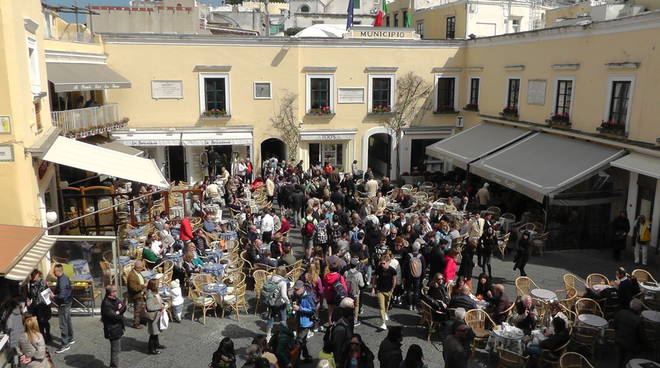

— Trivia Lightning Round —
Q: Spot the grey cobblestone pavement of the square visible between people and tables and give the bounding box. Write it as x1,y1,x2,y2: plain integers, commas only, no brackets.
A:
50,229,658,368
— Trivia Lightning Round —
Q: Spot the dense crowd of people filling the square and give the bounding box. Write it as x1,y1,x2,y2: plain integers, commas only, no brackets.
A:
2,160,656,368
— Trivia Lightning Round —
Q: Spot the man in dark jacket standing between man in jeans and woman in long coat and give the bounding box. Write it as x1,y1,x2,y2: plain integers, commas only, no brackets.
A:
101,285,126,368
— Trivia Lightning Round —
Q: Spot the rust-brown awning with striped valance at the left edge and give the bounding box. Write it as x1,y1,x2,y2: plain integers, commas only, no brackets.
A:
0,225,55,281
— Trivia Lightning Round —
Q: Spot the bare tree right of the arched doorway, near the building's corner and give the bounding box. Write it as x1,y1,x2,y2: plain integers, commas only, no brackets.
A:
383,72,433,179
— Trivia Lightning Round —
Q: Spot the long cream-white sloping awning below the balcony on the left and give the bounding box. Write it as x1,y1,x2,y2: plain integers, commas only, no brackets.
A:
43,137,169,188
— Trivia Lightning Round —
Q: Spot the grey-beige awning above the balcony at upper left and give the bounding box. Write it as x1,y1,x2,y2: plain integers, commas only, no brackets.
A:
46,63,131,92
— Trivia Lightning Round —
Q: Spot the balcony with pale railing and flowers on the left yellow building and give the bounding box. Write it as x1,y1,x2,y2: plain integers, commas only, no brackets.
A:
52,104,128,138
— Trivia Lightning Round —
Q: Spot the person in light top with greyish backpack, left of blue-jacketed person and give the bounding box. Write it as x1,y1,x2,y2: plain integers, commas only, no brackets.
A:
261,266,289,340
